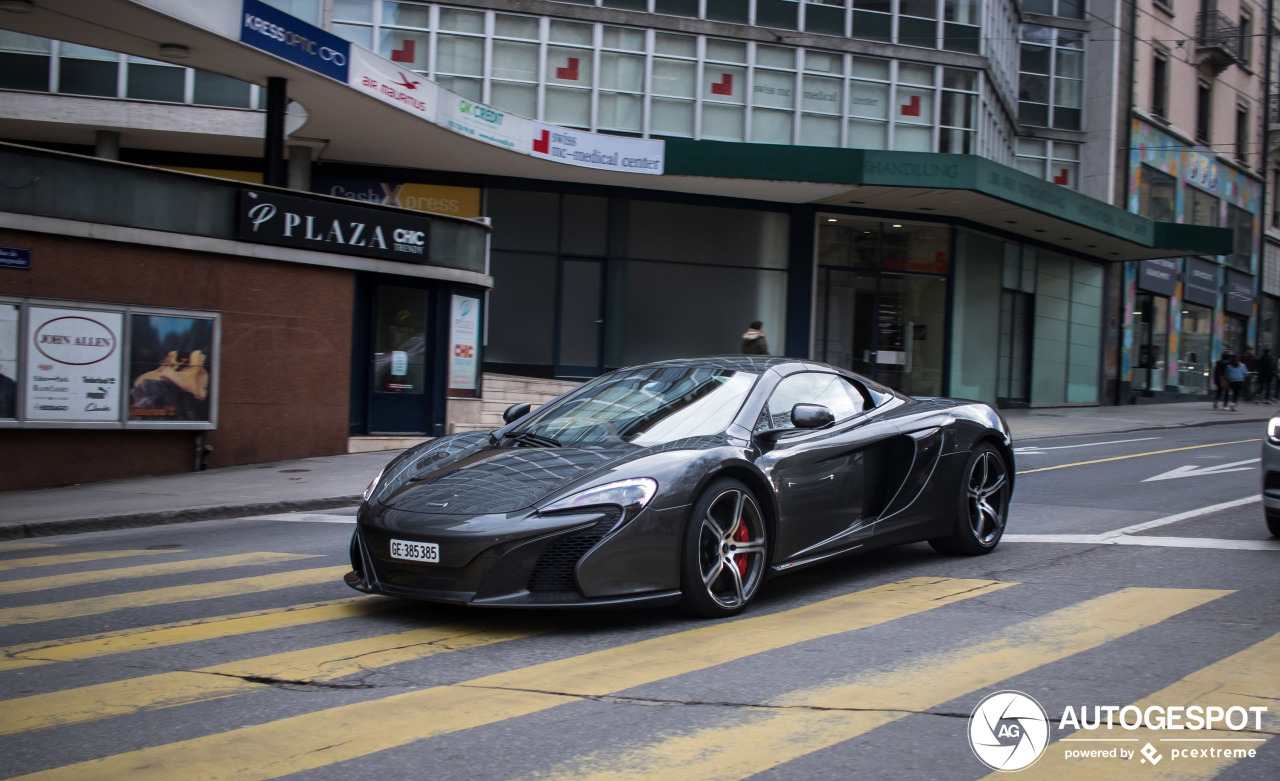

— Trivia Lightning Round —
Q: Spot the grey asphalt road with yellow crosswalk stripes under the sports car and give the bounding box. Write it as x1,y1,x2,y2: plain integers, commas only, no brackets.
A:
0,424,1280,781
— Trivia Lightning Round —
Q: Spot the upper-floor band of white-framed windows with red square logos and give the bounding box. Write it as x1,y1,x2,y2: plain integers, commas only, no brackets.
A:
333,0,982,148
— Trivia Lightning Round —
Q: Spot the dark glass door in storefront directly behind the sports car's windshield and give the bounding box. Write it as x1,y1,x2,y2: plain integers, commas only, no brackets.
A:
556,259,604,378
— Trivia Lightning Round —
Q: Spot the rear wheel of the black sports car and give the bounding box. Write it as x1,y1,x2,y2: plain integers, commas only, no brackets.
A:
929,442,1012,556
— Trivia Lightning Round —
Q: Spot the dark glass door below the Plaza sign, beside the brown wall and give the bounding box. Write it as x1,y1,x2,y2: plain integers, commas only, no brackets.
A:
369,284,431,434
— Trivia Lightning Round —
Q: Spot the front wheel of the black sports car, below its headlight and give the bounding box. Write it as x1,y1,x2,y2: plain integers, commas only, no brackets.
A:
680,478,769,618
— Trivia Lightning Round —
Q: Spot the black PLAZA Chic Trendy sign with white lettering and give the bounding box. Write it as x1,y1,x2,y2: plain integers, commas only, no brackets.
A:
237,189,431,264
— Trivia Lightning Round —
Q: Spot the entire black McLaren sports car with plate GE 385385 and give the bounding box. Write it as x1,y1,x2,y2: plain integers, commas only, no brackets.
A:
346,357,1014,617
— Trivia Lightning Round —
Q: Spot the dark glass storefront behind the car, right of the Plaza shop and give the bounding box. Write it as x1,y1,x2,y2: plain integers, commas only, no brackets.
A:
486,189,790,376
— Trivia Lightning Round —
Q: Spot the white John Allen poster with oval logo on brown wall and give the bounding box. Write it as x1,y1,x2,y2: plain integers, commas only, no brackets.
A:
23,306,124,423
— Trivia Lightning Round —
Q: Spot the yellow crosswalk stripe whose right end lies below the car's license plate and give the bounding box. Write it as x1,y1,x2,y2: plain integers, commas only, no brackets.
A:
0,597,398,672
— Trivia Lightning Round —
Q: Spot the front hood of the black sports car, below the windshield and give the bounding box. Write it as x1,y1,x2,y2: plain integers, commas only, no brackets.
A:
378,443,644,515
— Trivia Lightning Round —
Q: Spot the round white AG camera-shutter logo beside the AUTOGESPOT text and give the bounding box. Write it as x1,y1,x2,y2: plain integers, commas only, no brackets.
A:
969,691,1048,772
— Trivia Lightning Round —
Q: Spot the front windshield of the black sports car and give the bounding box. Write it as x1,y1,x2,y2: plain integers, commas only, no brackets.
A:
517,366,759,447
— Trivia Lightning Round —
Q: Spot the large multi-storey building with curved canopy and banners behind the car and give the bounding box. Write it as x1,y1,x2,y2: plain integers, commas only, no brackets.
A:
0,0,1231,486
